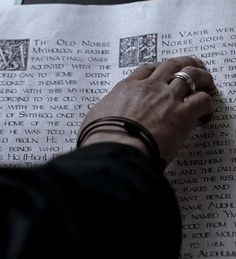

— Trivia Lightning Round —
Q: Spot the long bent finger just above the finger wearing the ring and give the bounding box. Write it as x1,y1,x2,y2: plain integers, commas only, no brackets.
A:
150,57,206,83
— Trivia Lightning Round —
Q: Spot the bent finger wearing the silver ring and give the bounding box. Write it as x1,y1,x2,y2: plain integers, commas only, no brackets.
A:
168,66,216,100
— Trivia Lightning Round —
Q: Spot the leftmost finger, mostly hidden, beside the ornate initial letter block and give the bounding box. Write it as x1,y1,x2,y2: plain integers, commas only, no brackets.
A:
127,62,161,80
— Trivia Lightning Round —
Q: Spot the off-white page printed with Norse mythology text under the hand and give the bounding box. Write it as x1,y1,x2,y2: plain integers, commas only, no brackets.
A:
0,0,236,259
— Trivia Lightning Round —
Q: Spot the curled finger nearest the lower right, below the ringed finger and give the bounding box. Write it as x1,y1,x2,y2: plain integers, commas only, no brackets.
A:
182,92,215,124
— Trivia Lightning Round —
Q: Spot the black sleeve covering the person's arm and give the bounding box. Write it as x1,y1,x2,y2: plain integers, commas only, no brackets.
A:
0,143,181,259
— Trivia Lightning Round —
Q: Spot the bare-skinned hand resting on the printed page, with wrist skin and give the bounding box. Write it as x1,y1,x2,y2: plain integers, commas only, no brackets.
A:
79,57,215,166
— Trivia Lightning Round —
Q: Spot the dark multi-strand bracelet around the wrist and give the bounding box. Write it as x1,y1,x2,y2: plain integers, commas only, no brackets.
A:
77,116,160,159
